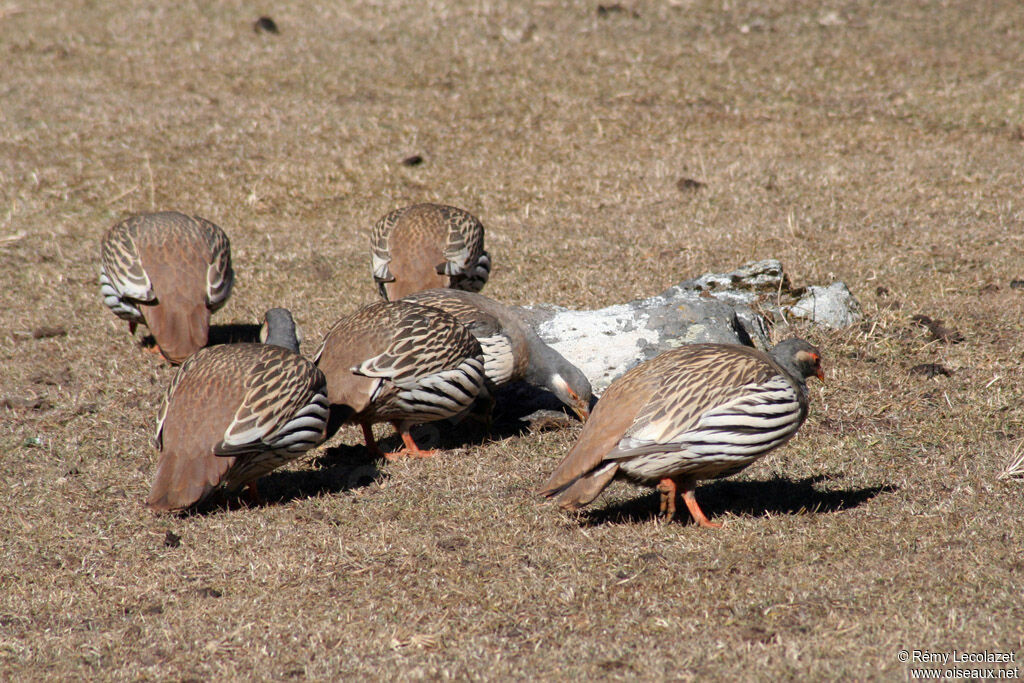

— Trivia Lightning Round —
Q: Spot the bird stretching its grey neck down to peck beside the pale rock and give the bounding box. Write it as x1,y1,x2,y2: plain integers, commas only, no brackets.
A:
402,289,592,422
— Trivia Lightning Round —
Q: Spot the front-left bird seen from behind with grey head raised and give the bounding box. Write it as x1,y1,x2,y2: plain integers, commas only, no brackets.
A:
147,308,330,511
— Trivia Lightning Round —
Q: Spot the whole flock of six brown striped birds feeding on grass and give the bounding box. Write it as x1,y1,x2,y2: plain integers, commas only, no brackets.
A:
99,204,823,527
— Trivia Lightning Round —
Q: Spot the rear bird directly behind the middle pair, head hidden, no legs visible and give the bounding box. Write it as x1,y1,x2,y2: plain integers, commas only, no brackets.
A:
370,204,490,301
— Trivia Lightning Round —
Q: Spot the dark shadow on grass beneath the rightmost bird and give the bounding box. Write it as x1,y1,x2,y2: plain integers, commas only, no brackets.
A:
580,474,898,526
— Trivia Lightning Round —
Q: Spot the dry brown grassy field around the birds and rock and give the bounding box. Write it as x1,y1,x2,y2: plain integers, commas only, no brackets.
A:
0,0,1024,680
